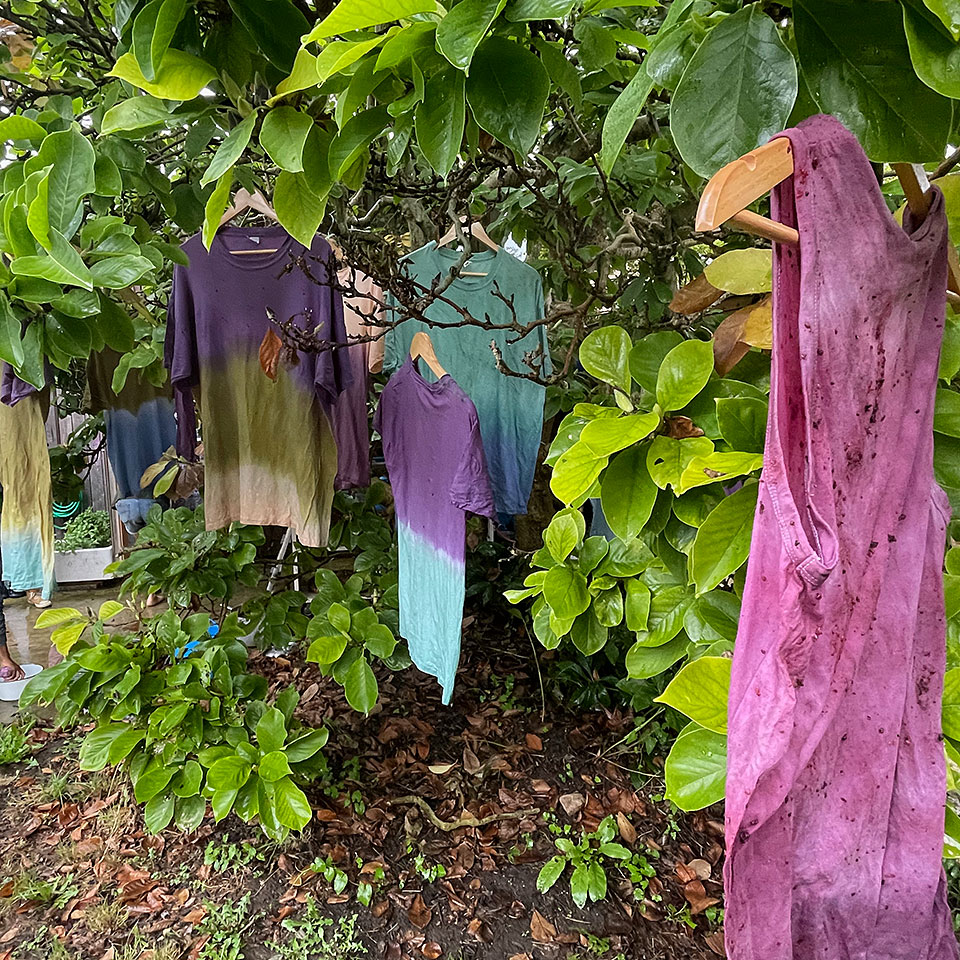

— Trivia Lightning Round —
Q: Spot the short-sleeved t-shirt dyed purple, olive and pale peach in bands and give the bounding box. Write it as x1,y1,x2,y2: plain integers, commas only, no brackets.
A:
166,226,349,547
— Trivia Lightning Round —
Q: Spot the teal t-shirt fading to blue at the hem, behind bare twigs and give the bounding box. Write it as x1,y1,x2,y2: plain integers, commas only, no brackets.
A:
384,242,551,514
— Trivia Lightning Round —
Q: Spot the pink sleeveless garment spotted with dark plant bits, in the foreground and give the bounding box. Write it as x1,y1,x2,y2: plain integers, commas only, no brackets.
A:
724,116,957,960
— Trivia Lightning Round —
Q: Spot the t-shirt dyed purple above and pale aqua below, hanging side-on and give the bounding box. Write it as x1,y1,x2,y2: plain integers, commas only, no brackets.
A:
374,358,494,703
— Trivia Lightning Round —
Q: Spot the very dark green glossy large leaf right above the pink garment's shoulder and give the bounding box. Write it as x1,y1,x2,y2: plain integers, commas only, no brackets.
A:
793,0,953,162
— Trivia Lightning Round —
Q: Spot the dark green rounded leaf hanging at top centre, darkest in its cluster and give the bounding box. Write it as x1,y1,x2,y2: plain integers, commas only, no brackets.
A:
467,36,550,154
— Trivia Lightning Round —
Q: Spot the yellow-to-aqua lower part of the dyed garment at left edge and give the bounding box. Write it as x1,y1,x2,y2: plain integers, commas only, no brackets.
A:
0,393,54,599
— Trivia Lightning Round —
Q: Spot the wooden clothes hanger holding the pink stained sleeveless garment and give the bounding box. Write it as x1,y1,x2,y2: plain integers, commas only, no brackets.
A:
696,137,960,304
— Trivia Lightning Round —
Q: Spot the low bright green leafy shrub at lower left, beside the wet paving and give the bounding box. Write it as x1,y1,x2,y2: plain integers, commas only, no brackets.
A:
21,601,328,840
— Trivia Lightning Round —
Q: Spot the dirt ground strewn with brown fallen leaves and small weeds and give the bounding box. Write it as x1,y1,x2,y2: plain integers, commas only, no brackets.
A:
0,595,723,960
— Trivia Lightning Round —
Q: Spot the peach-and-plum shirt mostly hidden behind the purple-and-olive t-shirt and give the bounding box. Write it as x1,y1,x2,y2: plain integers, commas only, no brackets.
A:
333,267,383,490
